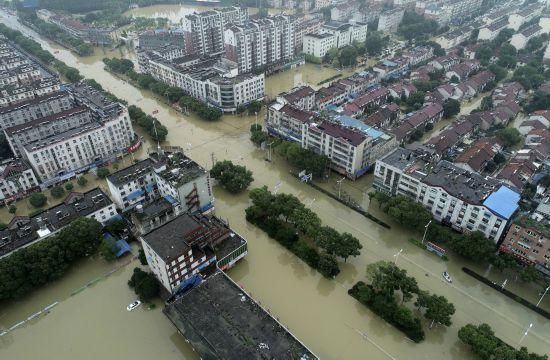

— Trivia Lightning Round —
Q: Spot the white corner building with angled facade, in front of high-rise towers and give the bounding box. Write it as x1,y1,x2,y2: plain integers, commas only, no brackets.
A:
140,53,265,112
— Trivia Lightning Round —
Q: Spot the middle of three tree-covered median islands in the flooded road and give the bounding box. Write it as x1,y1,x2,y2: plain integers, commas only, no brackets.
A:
354,261,455,342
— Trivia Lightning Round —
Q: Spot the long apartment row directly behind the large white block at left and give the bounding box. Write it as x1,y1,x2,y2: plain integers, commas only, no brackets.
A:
4,106,93,157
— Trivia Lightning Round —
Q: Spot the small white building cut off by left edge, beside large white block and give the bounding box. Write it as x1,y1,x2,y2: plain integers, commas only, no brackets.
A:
0,160,39,202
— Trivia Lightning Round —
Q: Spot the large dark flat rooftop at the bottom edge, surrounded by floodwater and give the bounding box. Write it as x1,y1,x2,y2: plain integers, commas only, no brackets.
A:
164,271,317,360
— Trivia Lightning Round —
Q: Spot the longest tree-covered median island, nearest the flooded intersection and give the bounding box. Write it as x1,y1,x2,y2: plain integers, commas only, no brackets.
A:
246,186,363,278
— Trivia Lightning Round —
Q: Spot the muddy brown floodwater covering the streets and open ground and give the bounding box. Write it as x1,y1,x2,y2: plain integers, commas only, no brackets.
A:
0,9,550,360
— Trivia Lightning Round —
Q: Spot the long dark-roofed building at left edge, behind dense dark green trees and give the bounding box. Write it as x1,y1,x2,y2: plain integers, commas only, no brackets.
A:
0,188,116,257
